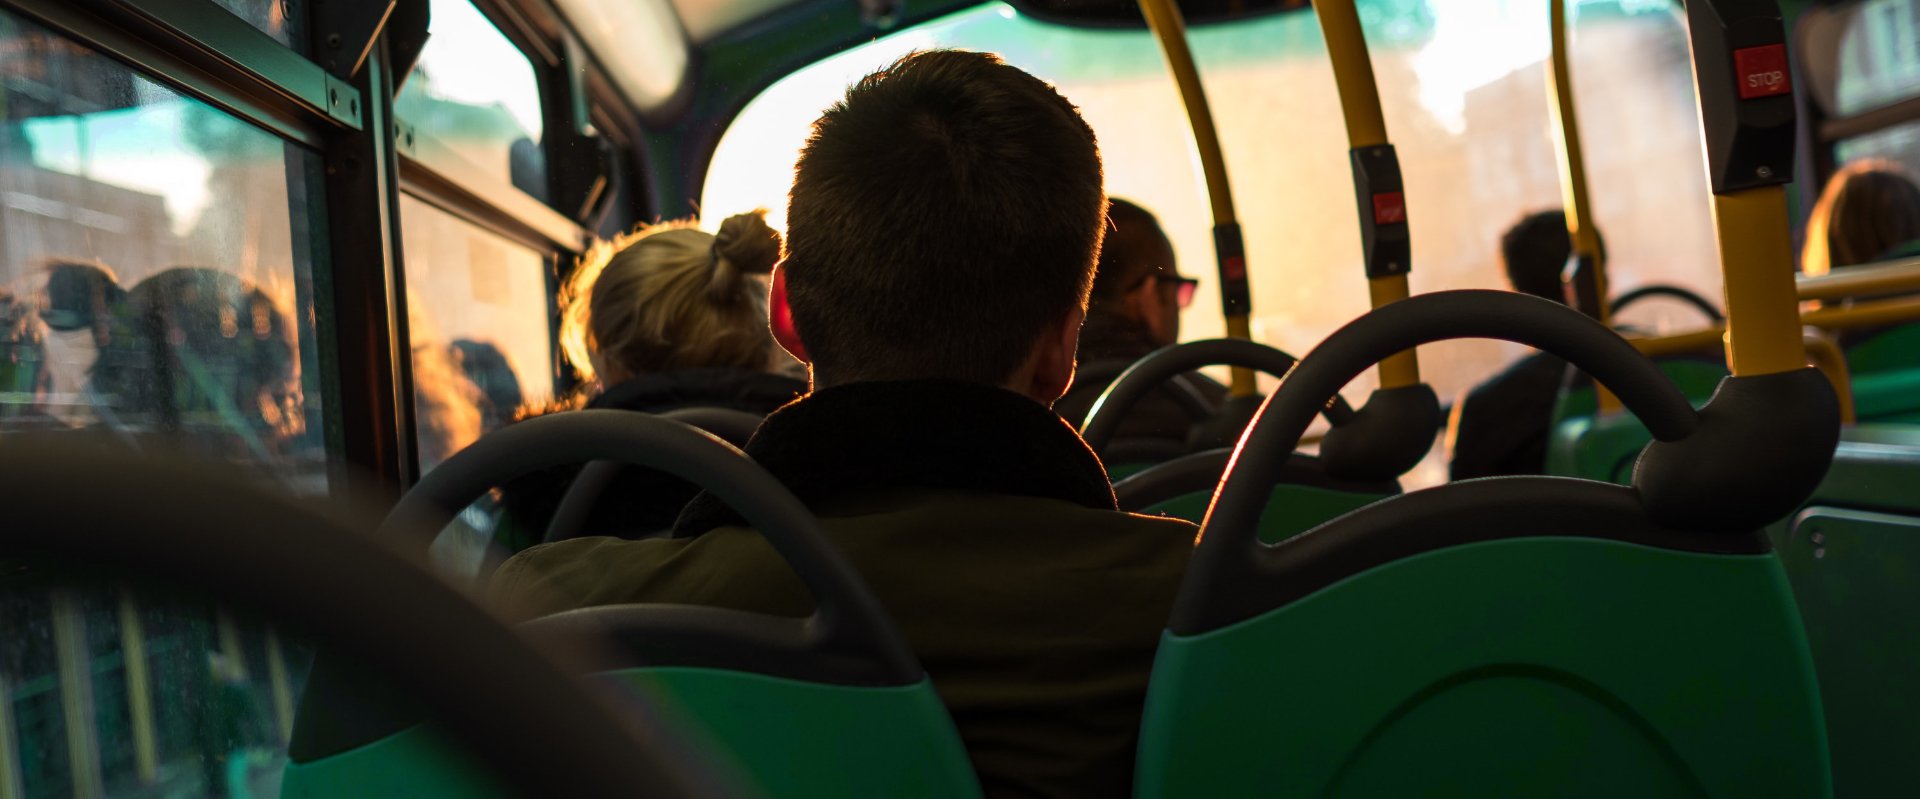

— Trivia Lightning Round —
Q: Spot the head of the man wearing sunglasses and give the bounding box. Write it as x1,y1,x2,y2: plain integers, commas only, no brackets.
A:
1087,200,1194,346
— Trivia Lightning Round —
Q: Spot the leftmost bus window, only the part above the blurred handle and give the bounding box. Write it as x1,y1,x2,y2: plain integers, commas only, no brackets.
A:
0,13,324,492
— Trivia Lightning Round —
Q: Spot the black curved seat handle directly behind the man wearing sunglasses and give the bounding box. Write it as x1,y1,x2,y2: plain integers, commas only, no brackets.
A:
1081,338,1354,451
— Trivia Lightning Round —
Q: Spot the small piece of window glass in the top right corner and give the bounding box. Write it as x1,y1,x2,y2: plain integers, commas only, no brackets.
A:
1836,0,1920,115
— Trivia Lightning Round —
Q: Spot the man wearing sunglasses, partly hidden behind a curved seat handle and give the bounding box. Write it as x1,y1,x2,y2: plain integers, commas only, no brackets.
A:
1054,200,1227,451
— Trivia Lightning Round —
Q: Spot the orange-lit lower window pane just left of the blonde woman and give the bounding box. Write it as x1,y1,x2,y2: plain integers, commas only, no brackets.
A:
399,196,555,469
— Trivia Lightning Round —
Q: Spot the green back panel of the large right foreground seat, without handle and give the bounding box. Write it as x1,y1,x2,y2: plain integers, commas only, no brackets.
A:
1137,533,1830,797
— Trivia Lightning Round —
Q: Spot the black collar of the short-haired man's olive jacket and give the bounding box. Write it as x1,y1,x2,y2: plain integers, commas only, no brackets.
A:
674,380,1116,536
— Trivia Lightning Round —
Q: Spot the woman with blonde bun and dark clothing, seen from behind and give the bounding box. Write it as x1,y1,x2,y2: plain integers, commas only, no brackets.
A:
501,211,806,549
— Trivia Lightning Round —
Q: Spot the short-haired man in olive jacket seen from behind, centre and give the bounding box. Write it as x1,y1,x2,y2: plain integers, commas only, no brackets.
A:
492,50,1196,797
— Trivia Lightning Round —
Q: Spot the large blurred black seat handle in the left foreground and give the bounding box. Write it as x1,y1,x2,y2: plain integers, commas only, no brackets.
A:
0,443,722,797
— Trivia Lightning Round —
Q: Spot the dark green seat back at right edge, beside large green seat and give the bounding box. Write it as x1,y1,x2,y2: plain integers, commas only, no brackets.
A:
1768,428,1920,797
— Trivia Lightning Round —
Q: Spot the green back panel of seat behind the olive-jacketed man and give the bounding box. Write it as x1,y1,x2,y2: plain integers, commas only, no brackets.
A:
282,666,979,799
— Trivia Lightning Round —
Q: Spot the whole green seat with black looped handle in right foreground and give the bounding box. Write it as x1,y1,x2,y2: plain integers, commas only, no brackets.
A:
1135,292,1837,797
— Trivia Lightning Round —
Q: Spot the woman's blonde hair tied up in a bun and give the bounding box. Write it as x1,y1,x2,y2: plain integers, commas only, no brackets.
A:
561,209,780,382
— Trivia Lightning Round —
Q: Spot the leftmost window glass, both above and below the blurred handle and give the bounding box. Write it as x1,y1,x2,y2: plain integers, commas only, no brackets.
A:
0,4,326,797
